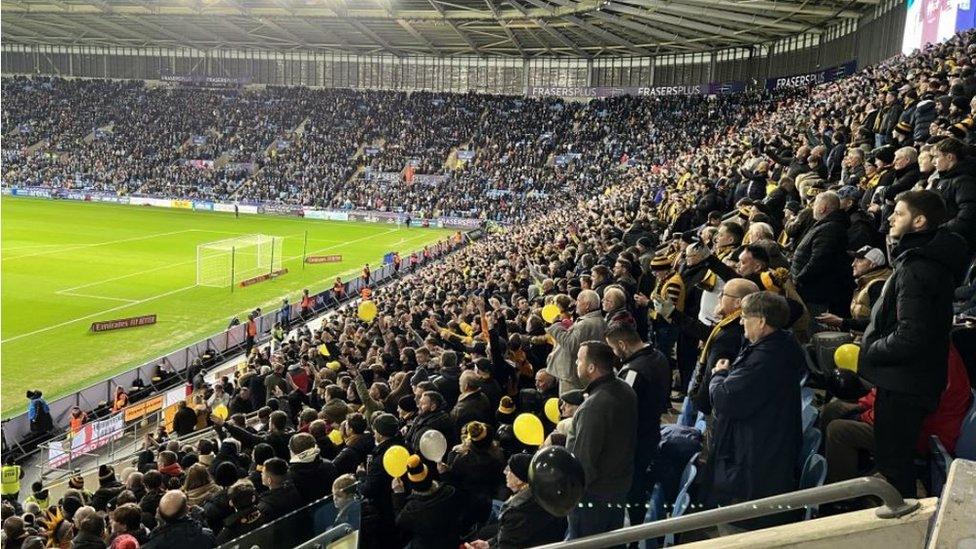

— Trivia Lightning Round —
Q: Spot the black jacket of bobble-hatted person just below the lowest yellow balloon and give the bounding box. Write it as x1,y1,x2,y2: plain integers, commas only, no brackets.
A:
393,484,461,549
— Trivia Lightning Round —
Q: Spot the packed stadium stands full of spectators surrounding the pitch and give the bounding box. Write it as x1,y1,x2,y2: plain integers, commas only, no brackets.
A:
3,15,976,549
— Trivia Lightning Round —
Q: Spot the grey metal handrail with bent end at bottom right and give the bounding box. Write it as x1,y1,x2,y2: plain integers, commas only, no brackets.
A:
535,477,919,549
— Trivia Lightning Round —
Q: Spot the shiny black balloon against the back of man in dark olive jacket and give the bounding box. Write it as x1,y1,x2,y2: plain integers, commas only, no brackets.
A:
529,446,586,517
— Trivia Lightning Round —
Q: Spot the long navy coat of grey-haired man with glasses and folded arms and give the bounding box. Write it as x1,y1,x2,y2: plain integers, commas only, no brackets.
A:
703,330,806,524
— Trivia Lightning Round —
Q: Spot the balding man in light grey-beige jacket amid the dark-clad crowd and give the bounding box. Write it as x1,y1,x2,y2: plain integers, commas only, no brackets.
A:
546,290,606,394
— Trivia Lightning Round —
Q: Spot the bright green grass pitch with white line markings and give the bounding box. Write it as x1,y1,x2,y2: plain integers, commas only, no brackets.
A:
0,197,453,417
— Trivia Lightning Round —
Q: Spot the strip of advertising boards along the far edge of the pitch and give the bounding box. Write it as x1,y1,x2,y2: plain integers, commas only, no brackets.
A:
3,187,482,229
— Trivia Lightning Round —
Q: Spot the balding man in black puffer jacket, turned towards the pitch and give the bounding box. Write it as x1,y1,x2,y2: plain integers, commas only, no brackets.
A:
790,191,854,315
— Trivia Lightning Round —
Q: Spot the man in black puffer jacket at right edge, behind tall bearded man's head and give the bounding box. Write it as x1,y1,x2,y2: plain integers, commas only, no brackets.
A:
934,137,976,248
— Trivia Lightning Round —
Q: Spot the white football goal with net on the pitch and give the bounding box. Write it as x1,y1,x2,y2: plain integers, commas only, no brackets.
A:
197,234,283,288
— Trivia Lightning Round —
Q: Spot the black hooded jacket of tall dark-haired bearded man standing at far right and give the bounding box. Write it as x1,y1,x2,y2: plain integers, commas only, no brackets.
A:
858,228,968,400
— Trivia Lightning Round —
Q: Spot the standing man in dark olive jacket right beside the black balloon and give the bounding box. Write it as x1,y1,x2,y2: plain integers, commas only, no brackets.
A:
566,340,638,539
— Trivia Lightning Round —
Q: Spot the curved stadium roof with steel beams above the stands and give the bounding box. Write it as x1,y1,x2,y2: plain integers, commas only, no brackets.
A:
0,0,879,57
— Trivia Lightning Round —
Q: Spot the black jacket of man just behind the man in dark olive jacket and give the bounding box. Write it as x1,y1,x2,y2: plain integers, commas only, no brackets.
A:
617,345,671,465
